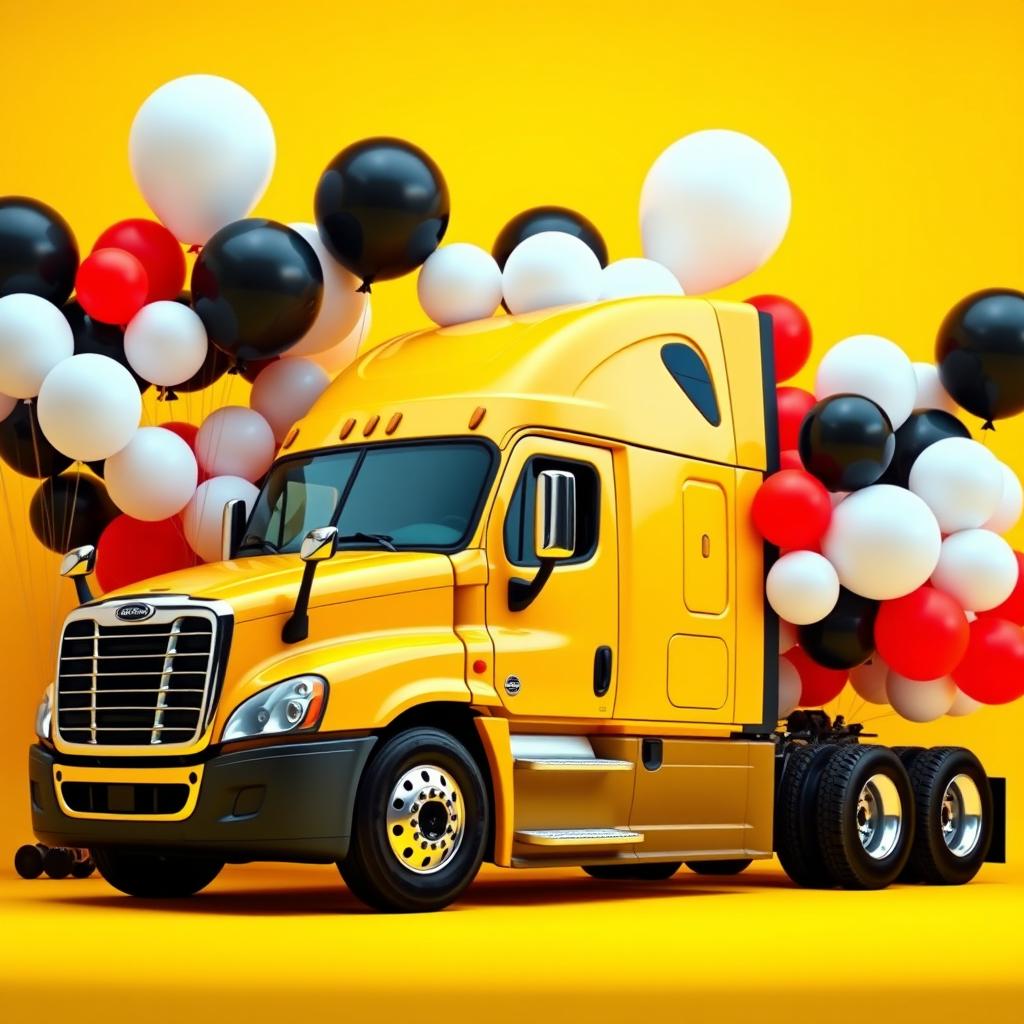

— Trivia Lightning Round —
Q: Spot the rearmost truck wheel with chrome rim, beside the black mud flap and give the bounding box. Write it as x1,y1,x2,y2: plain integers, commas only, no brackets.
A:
905,746,993,886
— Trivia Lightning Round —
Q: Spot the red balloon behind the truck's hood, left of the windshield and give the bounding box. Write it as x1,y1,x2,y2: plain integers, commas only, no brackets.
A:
96,515,200,592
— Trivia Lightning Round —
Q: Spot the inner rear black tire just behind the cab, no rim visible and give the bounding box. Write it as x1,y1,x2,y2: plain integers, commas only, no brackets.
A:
775,743,840,889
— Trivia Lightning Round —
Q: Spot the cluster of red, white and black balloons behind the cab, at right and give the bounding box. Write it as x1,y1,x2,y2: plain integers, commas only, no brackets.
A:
750,291,1024,722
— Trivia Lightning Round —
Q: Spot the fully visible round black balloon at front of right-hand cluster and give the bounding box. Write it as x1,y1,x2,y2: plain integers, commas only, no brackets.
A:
799,394,896,490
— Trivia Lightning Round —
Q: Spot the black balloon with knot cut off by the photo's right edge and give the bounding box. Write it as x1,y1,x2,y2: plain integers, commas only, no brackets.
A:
935,288,1024,427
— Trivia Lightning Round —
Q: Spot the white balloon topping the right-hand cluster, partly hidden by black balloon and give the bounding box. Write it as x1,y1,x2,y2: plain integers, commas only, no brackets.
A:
814,334,918,430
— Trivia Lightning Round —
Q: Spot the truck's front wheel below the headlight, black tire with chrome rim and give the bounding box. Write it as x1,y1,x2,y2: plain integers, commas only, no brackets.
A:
338,728,490,913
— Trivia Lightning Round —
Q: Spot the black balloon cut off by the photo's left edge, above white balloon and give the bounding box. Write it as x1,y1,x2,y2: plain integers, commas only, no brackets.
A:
0,196,78,306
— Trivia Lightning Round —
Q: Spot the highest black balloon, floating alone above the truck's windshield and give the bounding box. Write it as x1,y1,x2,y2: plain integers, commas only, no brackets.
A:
315,138,451,291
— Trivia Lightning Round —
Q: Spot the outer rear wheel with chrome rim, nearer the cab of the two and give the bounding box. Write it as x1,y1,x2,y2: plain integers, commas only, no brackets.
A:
818,746,913,889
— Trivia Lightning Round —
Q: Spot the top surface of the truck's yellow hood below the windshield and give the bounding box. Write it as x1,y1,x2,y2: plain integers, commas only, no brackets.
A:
103,551,454,623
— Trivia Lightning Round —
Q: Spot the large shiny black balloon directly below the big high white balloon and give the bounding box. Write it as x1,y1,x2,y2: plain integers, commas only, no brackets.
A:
191,218,324,360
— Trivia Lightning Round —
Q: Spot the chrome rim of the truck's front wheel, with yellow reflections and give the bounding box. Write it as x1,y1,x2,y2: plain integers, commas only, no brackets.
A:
386,765,466,874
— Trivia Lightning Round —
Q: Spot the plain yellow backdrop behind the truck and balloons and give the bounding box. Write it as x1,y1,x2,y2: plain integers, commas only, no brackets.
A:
0,0,1024,1014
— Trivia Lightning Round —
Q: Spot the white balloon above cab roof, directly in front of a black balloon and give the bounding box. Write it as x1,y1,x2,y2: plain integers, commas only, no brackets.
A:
502,231,601,313
